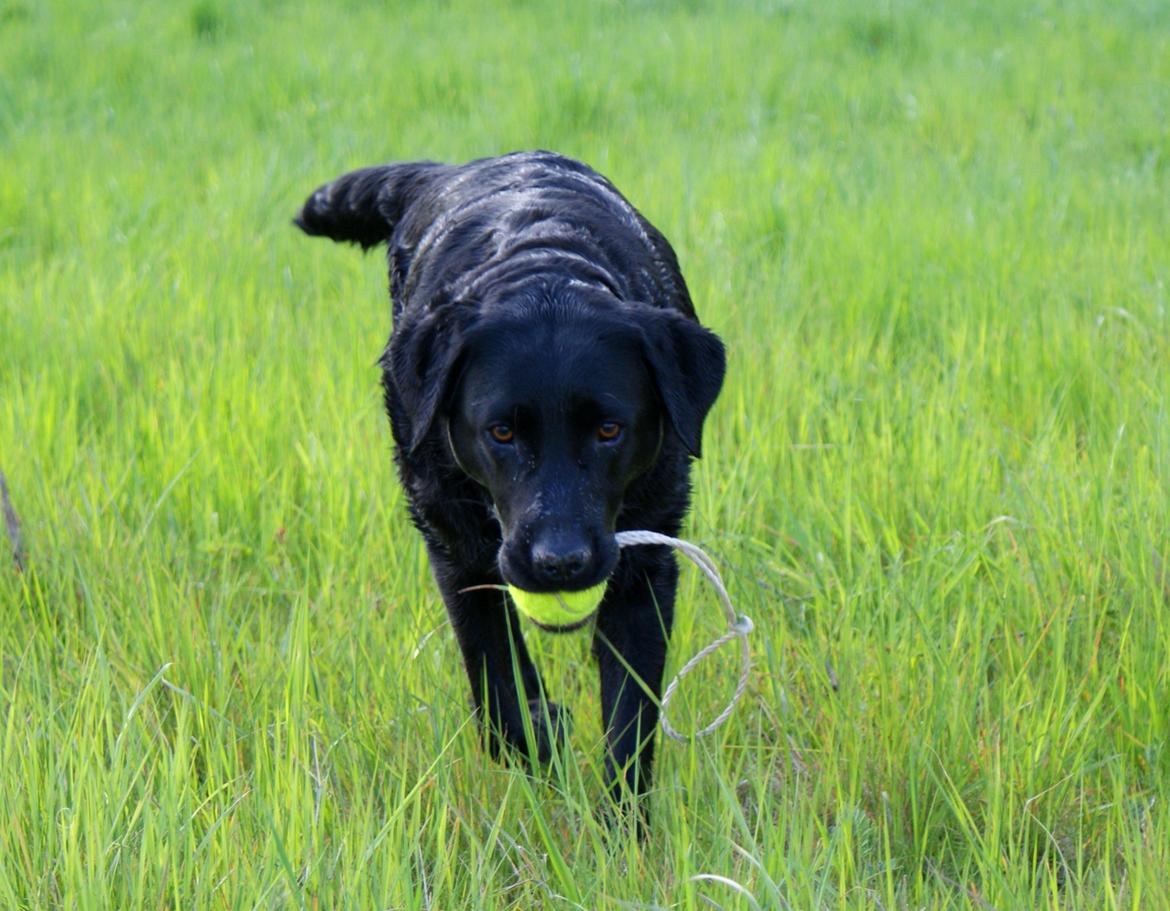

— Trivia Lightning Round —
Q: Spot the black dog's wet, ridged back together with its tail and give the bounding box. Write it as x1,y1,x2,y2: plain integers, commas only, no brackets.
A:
296,152,694,318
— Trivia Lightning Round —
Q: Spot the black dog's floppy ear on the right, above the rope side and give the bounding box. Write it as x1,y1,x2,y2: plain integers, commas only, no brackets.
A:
642,309,727,458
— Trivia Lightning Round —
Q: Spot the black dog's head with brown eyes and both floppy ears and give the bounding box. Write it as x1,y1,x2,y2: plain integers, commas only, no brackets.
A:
384,292,724,592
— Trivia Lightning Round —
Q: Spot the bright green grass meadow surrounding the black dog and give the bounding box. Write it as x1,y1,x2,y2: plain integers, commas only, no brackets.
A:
0,0,1170,911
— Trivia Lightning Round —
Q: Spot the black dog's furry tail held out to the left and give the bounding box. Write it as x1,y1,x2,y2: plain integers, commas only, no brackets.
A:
294,161,447,249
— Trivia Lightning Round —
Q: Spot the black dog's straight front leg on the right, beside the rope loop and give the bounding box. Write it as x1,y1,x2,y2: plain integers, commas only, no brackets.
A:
593,547,679,823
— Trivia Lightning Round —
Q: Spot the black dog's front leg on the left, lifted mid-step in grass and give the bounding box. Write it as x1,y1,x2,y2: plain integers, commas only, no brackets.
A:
432,553,567,762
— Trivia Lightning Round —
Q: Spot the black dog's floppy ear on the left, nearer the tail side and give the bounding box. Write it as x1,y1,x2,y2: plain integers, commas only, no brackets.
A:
379,304,470,455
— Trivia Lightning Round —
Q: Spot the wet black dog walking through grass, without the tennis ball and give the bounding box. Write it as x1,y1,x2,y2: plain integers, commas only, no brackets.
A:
296,152,724,818
